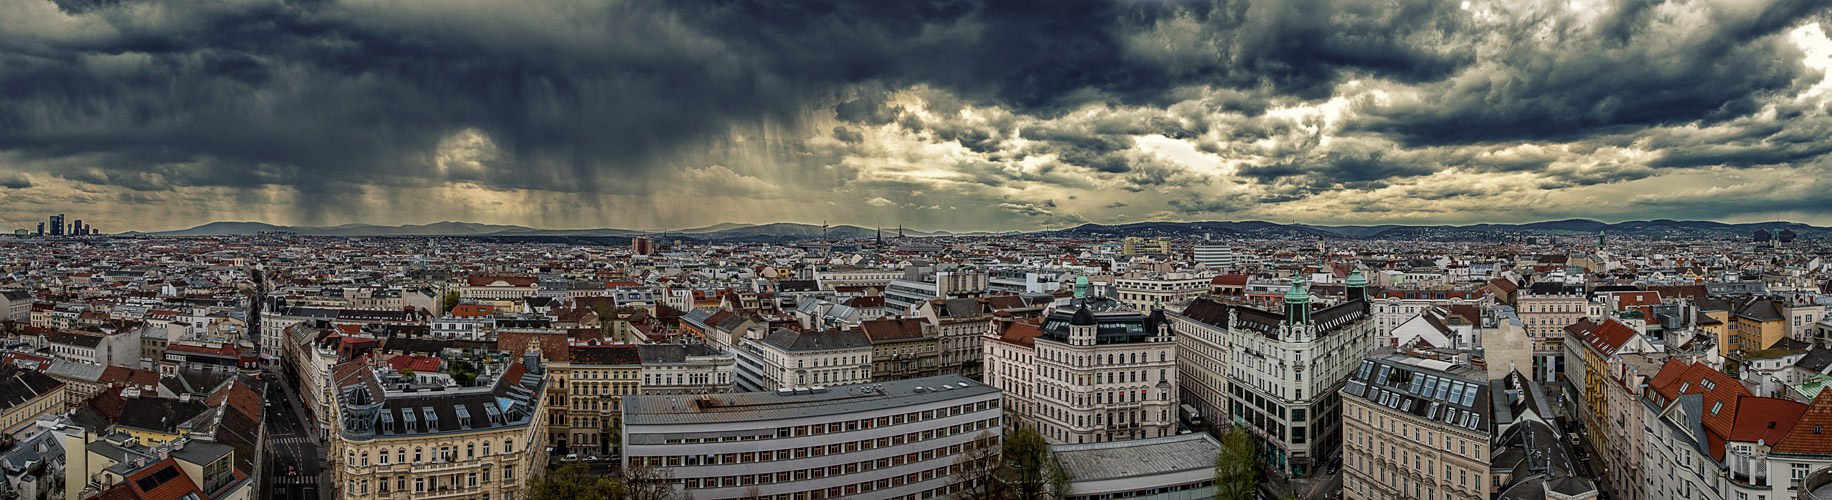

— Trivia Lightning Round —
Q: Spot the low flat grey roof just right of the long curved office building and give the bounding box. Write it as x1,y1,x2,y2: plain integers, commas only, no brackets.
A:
1050,432,1222,482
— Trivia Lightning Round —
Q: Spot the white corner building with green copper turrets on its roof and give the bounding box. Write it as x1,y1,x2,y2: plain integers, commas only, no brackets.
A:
1226,273,1381,476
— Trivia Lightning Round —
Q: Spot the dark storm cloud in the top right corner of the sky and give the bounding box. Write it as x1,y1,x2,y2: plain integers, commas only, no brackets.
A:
1354,0,1828,145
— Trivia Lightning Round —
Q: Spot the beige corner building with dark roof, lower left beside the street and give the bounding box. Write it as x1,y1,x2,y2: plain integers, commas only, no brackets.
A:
330,355,548,500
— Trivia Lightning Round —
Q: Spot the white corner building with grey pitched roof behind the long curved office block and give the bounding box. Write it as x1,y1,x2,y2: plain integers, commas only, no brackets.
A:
736,328,872,390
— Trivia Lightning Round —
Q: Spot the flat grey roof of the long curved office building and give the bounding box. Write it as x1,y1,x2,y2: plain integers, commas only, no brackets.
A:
623,375,998,425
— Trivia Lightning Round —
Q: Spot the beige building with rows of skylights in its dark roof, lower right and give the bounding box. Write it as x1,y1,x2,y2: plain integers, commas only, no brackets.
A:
1341,353,1493,500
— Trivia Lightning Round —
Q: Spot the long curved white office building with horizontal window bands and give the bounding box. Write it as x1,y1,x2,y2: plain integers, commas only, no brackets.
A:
623,375,1004,498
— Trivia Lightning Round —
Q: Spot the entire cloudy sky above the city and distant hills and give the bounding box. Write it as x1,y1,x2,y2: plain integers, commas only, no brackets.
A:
0,0,1832,233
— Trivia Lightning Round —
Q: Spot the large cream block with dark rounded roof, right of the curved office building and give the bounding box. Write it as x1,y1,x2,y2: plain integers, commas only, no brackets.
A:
1031,297,1178,443
